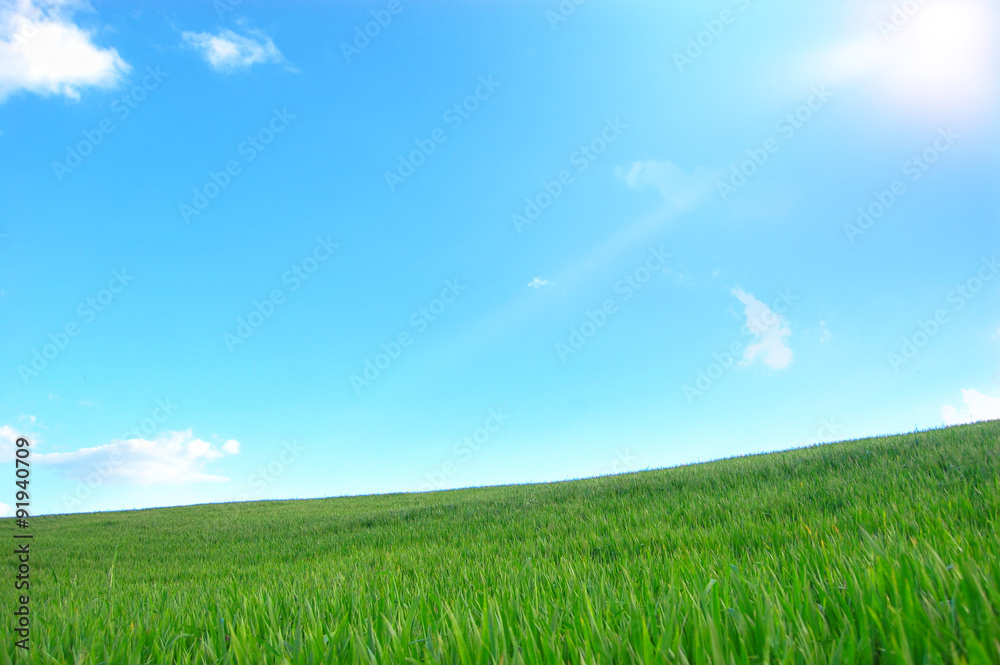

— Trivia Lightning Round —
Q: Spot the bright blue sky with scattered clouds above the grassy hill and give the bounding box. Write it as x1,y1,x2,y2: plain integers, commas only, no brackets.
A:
0,0,1000,513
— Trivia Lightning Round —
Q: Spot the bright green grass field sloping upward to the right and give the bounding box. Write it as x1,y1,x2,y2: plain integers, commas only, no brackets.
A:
2,421,1000,664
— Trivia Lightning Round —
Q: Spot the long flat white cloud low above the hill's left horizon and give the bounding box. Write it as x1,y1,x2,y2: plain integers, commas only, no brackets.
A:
36,430,240,485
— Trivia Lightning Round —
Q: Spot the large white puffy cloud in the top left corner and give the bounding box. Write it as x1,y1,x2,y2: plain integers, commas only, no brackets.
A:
0,0,131,102
